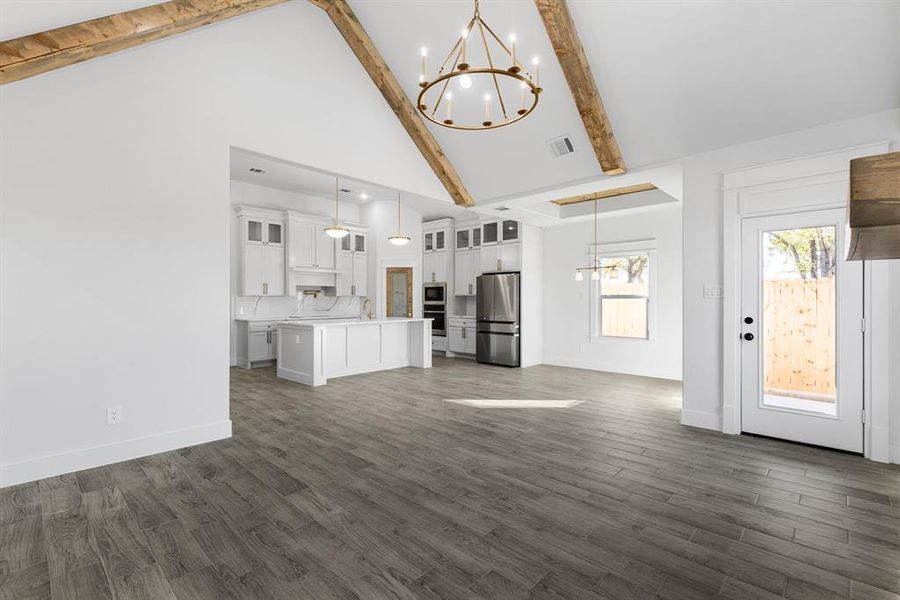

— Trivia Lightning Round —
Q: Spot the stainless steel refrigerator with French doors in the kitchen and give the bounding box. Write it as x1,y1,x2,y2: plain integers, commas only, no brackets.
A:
475,273,520,367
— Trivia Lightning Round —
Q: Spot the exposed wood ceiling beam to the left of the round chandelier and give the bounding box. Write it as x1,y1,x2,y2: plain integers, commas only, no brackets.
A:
310,0,475,206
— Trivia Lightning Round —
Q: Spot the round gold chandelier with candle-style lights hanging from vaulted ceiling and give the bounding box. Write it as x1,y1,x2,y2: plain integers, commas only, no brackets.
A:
416,0,543,131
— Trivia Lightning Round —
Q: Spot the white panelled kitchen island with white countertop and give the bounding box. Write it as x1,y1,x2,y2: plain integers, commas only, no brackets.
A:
277,318,431,386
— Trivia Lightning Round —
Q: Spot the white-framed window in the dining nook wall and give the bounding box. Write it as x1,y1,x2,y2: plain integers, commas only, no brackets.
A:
591,252,652,339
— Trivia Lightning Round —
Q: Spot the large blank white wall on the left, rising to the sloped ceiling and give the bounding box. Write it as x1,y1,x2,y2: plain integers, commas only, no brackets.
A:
0,2,446,485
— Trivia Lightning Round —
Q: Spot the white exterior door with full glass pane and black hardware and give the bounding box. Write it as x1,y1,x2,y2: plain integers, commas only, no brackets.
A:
739,209,863,452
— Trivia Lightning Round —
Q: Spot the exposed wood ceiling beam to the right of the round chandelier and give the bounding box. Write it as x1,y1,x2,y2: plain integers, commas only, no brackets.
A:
535,0,626,175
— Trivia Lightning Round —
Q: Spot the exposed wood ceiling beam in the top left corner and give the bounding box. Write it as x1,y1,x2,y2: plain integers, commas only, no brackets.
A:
0,0,286,84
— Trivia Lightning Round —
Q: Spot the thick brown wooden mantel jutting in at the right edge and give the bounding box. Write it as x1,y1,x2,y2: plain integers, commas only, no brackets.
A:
847,152,900,260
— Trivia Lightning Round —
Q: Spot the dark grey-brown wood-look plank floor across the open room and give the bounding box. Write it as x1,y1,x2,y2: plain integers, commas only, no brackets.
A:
0,359,900,600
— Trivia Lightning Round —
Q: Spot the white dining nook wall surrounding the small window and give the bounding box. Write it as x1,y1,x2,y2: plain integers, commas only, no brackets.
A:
544,204,682,379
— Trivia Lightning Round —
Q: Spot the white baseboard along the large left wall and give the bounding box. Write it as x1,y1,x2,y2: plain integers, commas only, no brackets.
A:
0,420,231,488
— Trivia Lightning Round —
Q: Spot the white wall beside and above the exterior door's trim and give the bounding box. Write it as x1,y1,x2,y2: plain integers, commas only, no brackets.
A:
682,110,900,450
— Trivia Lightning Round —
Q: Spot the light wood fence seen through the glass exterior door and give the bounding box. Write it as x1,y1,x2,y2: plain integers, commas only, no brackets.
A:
763,277,836,402
